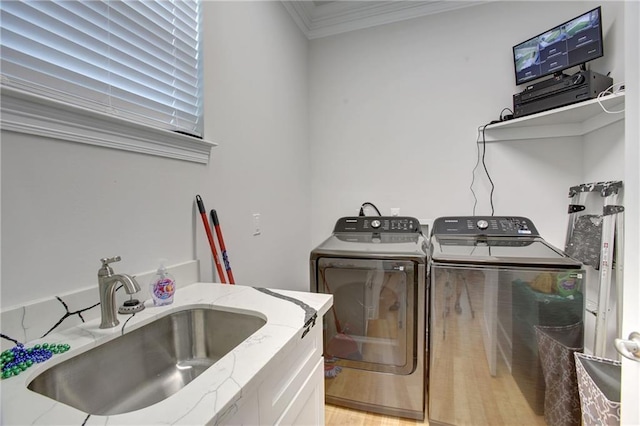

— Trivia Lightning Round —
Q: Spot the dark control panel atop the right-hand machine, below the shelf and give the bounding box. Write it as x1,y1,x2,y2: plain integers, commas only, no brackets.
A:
433,216,540,237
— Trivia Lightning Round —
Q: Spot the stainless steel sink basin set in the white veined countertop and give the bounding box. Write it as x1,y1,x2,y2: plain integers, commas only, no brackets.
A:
28,308,265,415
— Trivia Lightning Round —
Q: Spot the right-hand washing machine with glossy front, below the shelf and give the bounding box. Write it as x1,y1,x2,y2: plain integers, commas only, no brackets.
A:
429,216,584,425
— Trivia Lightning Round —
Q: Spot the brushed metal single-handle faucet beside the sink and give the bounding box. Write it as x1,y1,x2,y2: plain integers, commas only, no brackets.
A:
98,256,140,328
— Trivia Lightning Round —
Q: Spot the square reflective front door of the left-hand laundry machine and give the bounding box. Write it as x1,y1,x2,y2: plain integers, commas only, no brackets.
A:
316,258,418,374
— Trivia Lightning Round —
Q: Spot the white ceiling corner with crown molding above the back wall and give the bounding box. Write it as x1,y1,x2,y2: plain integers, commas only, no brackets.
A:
282,0,486,39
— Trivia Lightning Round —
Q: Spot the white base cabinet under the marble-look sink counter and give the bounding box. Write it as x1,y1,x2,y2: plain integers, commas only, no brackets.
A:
219,325,324,425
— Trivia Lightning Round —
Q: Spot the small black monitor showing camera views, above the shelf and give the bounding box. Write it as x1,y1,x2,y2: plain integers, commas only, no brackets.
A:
513,7,604,85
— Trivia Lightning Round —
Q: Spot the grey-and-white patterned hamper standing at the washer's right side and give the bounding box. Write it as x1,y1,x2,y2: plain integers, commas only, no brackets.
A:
574,352,621,426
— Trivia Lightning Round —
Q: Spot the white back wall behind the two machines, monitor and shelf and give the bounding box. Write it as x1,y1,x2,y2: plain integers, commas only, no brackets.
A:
310,1,624,250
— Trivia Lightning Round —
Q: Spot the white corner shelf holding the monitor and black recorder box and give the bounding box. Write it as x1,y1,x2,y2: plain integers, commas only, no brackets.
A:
480,93,625,142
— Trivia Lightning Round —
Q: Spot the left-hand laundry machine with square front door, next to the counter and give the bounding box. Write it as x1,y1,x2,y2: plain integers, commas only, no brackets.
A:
310,216,428,419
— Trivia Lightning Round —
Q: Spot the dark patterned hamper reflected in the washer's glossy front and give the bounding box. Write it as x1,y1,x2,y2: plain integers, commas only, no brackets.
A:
534,321,584,426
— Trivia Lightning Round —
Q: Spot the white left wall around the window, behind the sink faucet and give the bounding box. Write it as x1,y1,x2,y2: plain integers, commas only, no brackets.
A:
1,2,310,309
